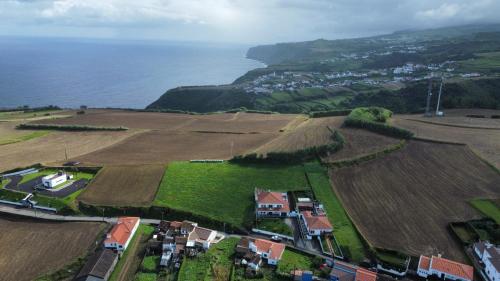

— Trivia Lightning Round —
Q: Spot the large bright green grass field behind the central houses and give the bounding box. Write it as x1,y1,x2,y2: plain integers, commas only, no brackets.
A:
153,162,308,227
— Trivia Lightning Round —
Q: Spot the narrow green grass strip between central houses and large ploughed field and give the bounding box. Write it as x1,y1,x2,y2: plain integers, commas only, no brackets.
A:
306,164,365,262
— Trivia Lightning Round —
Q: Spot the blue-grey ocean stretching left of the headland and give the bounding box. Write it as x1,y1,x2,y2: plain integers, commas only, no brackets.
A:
0,37,263,108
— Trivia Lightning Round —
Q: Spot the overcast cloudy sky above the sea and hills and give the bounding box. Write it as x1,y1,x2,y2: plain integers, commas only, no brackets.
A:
0,0,500,44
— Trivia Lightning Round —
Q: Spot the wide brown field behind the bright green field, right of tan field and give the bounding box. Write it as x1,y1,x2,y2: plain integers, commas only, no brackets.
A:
75,131,277,165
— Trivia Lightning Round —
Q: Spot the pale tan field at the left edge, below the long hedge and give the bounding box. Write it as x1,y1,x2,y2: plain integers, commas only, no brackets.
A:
0,128,136,171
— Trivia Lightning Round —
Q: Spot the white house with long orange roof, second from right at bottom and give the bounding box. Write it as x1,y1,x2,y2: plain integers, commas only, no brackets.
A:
417,255,474,281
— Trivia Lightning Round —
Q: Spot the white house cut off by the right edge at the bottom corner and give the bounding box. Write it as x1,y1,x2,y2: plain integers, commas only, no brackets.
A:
474,241,500,281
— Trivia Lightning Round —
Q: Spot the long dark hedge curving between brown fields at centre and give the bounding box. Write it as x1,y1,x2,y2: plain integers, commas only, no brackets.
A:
229,126,345,164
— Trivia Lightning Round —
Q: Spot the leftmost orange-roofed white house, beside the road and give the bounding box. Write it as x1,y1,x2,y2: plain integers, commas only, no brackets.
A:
104,217,141,251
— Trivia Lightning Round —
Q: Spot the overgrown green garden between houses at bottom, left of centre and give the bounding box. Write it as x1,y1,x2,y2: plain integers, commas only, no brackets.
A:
178,238,239,281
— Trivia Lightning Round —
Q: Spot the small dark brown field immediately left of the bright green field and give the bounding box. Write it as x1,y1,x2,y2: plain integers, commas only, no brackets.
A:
78,165,165,206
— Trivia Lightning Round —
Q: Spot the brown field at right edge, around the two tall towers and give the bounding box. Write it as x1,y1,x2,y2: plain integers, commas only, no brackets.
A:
393,111,500,168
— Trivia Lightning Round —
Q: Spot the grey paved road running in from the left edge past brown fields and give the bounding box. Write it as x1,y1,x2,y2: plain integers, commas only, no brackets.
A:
0,204,160,224
